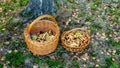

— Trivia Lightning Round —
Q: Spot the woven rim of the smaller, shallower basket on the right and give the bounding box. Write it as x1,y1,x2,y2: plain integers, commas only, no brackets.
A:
61,28,90,49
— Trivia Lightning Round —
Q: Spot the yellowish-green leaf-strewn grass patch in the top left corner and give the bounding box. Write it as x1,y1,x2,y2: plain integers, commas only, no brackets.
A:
0,0,29,24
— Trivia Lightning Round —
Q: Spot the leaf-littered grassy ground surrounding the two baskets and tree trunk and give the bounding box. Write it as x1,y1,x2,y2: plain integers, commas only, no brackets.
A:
0,0,120,68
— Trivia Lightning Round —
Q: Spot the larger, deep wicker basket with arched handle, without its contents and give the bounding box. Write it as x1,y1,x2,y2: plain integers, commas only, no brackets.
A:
24,15,60,55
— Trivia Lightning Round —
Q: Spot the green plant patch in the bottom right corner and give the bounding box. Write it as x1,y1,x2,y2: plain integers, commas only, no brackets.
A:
104,57,119,68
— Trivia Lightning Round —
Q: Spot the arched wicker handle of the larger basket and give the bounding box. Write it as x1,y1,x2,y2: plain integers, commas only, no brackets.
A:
28,14,57,32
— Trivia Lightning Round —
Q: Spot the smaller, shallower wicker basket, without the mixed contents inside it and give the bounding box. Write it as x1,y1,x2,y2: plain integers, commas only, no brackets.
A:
61,28,90,53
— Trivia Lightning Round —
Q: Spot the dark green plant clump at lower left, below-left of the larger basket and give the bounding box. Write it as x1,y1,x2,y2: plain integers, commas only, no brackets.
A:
6,51,25,66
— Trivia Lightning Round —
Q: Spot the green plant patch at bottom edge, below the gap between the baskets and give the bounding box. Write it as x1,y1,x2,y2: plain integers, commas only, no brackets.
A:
46,59,65,68
